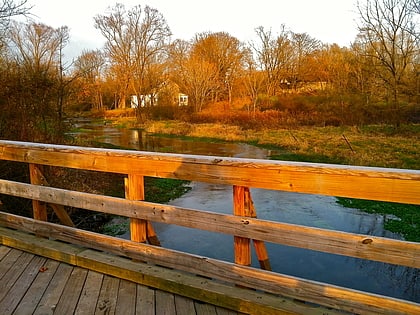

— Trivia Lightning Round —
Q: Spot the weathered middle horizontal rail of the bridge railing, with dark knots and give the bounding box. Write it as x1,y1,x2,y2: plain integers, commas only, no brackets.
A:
0,180,420,268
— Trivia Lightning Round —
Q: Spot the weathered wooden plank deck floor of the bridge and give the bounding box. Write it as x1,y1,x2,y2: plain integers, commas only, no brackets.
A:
0,246,238,315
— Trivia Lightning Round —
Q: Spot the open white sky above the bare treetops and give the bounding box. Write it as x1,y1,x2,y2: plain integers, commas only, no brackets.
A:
24,0,357,58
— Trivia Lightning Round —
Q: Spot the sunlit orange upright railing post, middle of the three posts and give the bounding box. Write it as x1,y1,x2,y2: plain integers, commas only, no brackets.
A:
124,174,147,243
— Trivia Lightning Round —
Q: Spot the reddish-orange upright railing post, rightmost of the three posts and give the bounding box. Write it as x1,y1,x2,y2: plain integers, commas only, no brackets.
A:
233,186,251,266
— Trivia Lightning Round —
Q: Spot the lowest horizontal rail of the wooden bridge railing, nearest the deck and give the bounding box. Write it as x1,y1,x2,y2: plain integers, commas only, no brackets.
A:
0,217,420,315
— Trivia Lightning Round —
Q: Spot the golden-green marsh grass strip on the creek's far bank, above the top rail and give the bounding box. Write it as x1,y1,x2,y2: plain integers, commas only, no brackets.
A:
143,121,420,169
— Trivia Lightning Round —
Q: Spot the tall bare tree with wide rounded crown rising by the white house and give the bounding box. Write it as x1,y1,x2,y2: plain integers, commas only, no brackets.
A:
95,4,171,108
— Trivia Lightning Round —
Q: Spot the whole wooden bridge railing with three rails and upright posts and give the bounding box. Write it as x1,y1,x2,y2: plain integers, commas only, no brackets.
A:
0,141,420,314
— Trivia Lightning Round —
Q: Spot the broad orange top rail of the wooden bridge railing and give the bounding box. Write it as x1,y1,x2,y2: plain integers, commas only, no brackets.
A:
0,140,420,204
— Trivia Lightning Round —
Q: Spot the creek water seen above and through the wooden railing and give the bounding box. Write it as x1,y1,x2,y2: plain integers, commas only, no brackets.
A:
72,120,420,302
